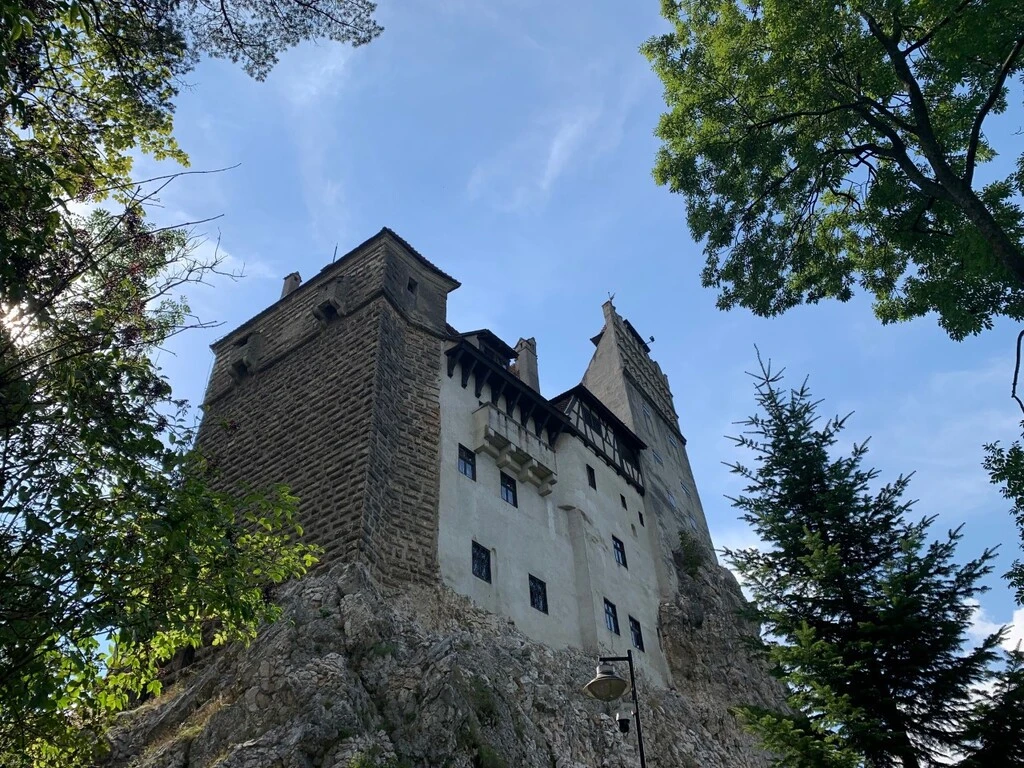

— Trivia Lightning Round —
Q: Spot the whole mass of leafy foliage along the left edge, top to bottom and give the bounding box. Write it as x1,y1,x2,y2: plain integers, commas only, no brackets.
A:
0,0,381,765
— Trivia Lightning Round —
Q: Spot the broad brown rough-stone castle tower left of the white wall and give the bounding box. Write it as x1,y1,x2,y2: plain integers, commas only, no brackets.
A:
199,228,459,584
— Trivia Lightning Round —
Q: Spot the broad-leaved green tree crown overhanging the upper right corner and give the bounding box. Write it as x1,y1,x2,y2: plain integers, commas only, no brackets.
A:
643,0,1024,339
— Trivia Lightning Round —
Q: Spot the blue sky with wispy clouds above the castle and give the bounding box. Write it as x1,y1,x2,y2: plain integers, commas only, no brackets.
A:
138,0,1024,647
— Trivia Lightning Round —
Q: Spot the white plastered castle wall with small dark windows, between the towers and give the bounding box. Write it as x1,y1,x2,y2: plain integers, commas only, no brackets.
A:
437,361,669,685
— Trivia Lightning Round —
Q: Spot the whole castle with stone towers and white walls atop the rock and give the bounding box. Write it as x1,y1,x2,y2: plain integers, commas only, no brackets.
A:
199,228,711,685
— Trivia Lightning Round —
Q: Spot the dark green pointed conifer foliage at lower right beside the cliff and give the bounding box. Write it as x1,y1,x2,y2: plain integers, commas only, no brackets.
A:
726,367,1024,768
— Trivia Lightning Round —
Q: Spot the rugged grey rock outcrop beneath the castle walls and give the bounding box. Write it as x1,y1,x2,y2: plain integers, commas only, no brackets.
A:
110,553,779,768
